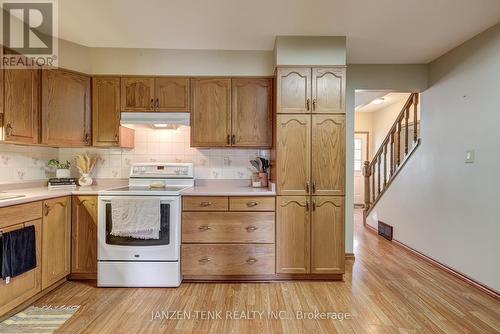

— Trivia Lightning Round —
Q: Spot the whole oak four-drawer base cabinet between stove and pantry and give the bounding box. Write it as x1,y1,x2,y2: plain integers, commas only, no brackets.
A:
181,196,276,281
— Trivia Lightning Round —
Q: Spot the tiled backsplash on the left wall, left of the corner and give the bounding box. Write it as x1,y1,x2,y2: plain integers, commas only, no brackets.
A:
0,144,59,183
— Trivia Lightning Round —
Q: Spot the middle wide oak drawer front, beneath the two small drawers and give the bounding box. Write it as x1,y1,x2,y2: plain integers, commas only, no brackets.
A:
182,212,274,243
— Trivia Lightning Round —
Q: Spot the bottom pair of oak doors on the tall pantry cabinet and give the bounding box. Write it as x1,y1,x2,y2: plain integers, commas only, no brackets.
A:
276,196,345,274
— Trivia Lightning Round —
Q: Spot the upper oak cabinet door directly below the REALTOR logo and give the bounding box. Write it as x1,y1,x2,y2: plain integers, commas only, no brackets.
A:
3,70,40,144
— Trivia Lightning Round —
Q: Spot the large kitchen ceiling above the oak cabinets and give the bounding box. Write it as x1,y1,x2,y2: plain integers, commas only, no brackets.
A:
59,0,500,64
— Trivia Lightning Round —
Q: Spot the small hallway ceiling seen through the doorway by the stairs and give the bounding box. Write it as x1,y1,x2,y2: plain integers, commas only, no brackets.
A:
354,90,410,112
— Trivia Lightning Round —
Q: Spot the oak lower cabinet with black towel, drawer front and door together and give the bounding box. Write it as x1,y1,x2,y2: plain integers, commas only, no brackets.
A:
0,202,42,317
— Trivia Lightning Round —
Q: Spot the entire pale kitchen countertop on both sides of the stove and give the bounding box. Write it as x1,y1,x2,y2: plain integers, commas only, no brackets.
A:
0,179,276,208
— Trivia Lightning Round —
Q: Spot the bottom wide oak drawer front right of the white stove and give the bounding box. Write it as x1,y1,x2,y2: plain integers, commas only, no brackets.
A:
181,244,275,275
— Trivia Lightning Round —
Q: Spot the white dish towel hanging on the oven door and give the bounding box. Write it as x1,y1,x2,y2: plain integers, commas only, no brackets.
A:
111,197,161,239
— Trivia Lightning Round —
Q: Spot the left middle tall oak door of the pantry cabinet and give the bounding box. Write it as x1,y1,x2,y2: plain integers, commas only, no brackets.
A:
276,115,311,195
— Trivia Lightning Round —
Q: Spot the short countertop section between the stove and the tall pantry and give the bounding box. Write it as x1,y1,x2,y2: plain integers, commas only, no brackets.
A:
181,180,276,196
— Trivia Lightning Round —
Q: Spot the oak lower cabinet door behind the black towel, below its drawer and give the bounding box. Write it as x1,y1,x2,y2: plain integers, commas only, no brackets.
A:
0,219,42,316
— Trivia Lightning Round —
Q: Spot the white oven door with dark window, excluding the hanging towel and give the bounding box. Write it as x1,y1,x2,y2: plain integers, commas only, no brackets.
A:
98,196,181,261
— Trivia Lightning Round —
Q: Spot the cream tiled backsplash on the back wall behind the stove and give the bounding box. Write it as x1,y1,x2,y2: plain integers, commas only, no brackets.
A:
59,126,270,179
